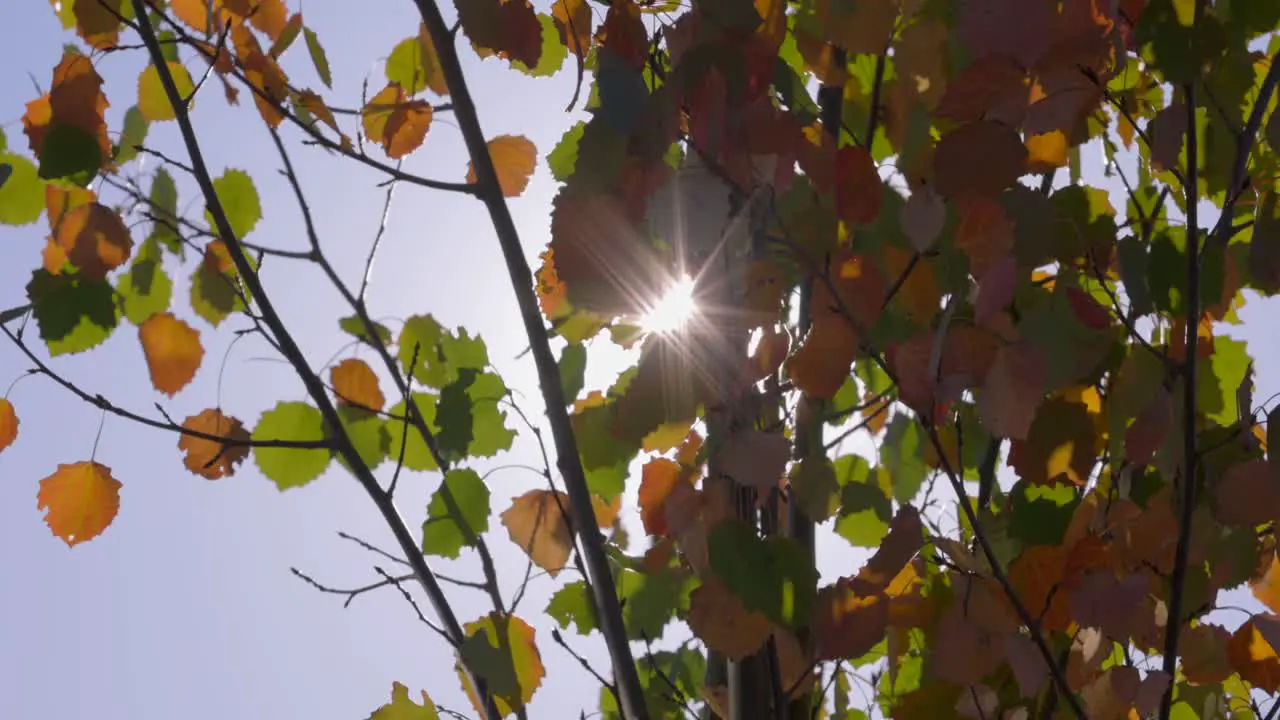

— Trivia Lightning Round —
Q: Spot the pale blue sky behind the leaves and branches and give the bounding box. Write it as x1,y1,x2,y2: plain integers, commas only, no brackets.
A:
0,0,1280,720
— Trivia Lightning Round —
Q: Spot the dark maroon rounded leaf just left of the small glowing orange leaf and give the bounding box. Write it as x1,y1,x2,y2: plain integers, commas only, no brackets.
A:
933,120,1027,197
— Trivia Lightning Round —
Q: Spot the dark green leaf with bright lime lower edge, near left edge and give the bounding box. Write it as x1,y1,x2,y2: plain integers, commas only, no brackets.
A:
27,269,120,356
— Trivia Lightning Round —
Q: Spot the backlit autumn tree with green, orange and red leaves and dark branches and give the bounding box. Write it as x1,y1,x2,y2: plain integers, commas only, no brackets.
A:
0,0,1280,720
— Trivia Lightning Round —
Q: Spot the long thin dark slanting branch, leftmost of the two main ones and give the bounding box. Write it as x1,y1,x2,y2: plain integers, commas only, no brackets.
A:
131,7,502,720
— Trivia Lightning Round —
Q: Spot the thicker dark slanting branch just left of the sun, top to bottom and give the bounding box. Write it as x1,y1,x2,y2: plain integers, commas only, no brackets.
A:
409,0,649,720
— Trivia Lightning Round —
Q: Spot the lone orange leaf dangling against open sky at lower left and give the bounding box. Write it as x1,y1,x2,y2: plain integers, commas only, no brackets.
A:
36,460,123,547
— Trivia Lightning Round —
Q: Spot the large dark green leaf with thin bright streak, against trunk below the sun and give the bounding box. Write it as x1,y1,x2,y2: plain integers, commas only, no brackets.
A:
707,520,818,626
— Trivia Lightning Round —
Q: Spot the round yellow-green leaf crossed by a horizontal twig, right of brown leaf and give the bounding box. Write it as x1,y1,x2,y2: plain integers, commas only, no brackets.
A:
252,402,332,491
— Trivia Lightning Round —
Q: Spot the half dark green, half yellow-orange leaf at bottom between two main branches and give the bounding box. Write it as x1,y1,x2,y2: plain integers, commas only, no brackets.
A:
458,612,547,716
